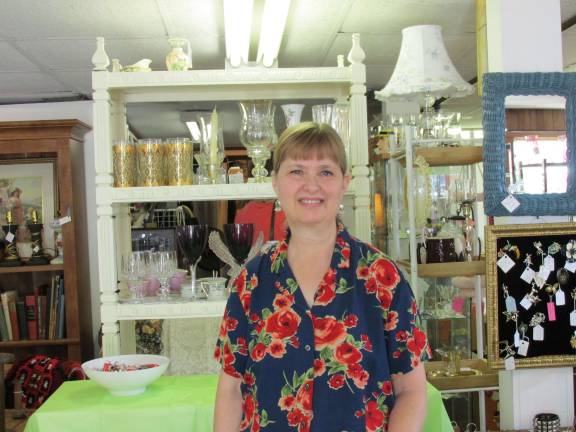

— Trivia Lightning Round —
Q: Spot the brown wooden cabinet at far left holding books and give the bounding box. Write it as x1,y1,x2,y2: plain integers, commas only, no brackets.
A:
0,120,92,360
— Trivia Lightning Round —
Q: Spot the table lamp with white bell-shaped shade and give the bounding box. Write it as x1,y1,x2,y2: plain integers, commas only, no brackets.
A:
375,25,473,138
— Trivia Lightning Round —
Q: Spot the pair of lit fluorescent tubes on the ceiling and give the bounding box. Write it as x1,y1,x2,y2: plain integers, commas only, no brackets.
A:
224,0,290,67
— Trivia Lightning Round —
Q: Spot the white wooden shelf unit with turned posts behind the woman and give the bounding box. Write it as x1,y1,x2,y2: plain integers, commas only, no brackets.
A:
92,36,370,355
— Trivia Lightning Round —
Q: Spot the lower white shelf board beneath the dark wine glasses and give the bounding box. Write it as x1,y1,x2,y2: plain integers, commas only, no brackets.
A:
108,300,226,320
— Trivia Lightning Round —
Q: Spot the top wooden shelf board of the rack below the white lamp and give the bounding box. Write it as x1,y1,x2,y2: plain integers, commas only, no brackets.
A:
383,146,483,167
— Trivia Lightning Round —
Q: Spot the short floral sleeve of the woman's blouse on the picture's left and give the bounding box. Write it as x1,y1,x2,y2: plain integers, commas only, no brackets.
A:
214,269,248,378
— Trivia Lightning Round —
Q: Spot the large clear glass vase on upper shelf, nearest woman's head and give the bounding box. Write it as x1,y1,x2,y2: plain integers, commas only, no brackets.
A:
238,100,277,183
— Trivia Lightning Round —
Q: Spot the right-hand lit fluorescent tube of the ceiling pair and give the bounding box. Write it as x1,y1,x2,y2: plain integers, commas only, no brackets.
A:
257,0,290,67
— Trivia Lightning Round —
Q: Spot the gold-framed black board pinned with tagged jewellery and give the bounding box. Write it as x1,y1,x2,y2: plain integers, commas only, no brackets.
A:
485,223,576,368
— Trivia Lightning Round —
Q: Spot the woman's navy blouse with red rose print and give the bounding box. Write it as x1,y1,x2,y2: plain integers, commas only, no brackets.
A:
214,226,428,432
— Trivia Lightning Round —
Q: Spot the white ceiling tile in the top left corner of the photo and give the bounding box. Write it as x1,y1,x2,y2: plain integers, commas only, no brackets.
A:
0,0,165,39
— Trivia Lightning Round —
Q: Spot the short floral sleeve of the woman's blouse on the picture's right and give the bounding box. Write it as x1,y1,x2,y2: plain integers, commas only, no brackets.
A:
384,268,429,374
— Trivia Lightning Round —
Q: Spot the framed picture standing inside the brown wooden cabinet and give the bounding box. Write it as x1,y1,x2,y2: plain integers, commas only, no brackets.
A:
0,159,58,251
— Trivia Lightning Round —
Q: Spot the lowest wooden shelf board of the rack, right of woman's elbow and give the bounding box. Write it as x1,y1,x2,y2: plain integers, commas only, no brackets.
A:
424,359,498,391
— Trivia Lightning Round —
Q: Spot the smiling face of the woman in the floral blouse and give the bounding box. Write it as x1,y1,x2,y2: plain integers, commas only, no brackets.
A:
272,157,350,230
